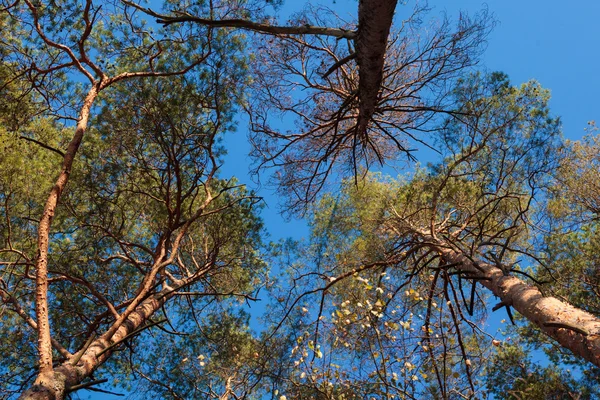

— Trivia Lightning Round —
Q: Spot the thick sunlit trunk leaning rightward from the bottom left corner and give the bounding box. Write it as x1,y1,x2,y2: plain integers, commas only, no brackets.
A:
19,288,173,400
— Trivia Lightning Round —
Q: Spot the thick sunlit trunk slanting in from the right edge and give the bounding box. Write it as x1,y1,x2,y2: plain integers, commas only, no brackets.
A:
429,238,600,367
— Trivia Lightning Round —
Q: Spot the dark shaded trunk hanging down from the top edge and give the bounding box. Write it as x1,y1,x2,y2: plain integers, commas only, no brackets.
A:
356,0,398,137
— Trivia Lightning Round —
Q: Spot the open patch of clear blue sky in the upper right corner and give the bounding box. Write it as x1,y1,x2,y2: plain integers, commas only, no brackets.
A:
458,0,600,140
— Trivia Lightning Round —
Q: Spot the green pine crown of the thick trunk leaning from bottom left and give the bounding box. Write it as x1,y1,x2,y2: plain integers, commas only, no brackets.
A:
47,69,265,380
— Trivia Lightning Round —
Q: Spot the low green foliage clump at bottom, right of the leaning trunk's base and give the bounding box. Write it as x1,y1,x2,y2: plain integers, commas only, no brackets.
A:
125,310,263,399
